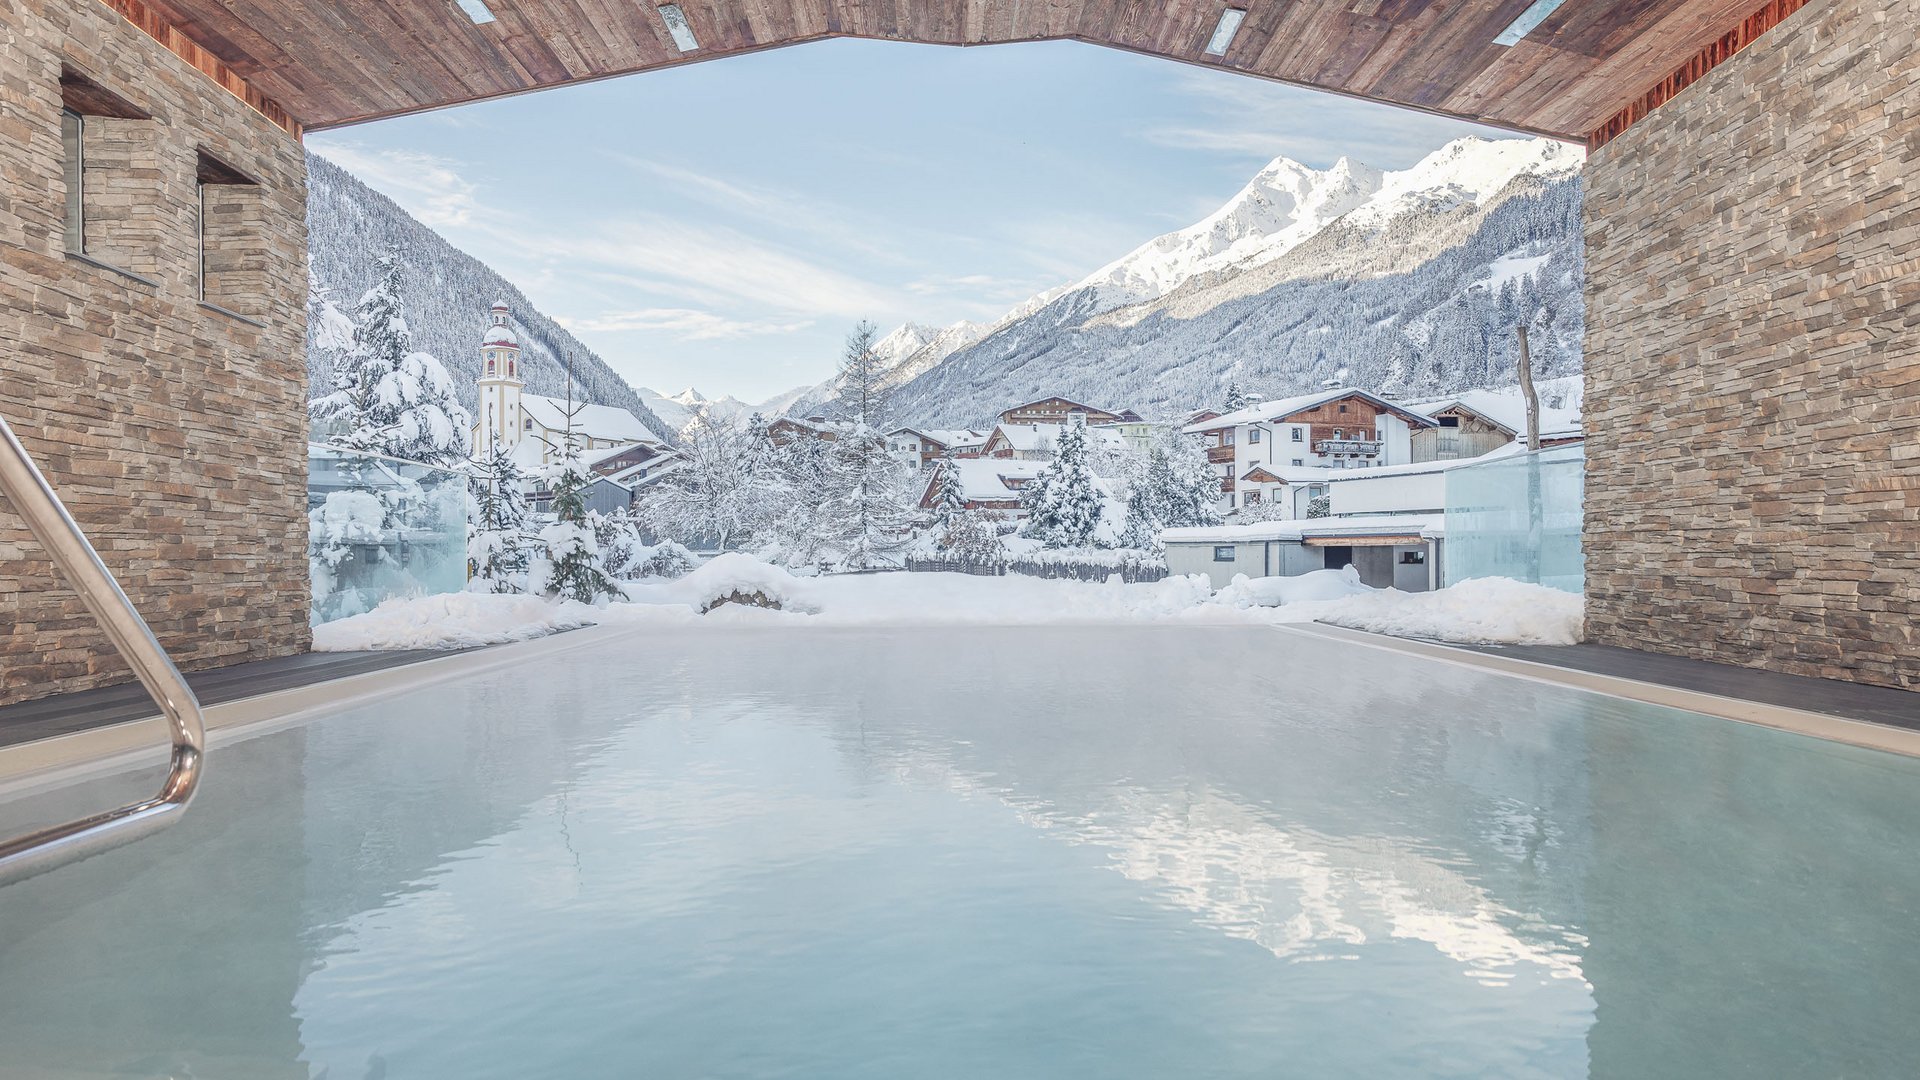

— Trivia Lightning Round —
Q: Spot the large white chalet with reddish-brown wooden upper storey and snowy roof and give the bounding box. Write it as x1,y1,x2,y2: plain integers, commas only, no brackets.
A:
1181,388,1434,511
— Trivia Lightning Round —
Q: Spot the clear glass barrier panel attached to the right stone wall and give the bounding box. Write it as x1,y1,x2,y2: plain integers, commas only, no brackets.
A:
1442,444,1586,592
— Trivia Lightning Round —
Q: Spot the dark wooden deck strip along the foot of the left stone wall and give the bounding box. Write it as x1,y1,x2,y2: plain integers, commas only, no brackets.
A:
0,650,451,748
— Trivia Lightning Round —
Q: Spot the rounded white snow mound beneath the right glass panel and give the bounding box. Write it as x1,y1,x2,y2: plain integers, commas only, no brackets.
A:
1297,578,1586,646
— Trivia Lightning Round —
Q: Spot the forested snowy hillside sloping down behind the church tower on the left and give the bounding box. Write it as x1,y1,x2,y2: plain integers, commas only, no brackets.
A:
307,154,678,438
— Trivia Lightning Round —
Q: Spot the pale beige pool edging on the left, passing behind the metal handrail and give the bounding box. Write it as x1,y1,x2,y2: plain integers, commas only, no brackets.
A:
0,626,630,799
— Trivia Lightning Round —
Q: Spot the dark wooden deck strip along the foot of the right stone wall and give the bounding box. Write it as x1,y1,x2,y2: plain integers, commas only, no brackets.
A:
1475,646,1920,730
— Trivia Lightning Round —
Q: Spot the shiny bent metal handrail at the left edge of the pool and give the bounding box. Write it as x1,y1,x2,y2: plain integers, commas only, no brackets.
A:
0,407,205,884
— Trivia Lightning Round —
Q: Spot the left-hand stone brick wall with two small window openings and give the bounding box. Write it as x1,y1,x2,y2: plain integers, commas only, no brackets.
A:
0,0,309,703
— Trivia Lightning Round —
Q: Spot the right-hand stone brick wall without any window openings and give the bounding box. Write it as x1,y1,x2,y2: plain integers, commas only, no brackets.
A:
1586,0,1920,690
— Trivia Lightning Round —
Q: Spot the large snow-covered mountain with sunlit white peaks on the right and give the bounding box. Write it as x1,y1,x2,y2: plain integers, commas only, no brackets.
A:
797,138,1584,427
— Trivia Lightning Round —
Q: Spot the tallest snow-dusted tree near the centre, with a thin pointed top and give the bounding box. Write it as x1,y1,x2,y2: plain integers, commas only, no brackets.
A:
824,323,912,571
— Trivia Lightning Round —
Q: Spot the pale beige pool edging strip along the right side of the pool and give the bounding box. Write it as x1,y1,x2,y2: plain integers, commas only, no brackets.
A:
1273,623,1920,757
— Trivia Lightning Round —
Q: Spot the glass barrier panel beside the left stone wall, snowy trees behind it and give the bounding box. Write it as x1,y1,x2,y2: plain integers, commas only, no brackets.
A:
307,446,467,626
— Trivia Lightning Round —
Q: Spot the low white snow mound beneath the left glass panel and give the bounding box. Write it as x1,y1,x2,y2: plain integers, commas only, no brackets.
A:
313,592,597,653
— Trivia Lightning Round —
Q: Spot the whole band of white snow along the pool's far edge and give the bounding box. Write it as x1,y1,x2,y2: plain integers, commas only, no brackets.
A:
313,555,1582,651
